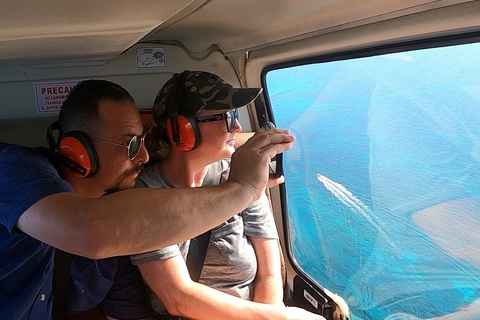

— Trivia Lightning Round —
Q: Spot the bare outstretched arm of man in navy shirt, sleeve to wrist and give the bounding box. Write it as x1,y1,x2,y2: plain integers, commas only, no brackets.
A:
17,182,254,258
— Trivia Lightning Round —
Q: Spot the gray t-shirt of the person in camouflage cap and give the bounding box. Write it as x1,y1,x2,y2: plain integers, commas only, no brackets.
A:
131,159,278,312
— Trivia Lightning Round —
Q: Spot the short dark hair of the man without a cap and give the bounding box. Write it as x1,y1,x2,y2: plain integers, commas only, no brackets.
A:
58,79,135,135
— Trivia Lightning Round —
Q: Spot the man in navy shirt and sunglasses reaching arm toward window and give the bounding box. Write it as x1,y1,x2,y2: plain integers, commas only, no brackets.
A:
0,80,300,319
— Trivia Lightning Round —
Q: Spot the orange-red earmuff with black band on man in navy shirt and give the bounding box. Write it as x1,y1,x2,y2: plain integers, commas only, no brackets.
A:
47,121,98,178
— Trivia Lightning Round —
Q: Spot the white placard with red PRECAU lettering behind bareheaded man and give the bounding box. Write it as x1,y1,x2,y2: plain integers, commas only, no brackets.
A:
34,80,78,113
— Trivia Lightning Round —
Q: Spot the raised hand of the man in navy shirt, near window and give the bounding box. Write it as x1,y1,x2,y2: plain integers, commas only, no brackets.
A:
228,129,295,199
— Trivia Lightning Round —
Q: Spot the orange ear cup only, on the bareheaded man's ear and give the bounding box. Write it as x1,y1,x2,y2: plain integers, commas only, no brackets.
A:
57,131,98,178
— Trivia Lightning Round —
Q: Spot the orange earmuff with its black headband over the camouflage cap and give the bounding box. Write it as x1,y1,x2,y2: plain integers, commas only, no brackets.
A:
165,70,201,151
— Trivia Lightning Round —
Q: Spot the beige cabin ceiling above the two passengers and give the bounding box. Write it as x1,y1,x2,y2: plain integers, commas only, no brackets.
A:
0,0,469,65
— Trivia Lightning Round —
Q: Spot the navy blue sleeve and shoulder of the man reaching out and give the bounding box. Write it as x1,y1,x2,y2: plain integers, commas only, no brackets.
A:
0,145,74,233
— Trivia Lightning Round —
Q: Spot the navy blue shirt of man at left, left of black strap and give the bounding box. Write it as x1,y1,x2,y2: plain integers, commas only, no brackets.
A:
0,144,73,320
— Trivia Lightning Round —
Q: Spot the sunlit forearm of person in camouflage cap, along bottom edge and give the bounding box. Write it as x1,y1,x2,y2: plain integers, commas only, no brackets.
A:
138,256,325,320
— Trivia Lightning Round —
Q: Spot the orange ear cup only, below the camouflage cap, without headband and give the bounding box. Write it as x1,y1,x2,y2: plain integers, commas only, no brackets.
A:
165,115,201,151
